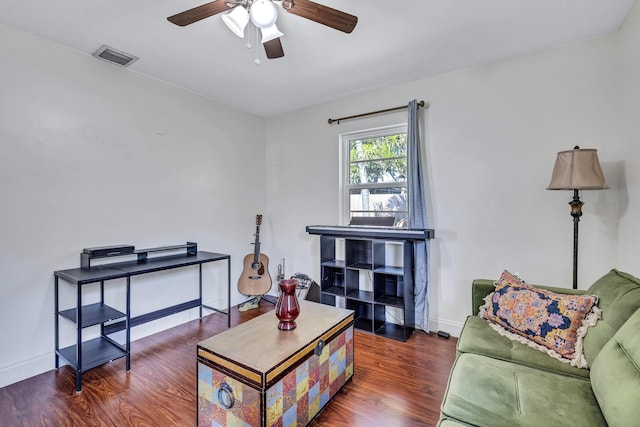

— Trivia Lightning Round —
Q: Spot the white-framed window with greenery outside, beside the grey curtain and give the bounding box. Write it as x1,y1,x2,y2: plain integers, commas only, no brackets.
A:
341,125,408,227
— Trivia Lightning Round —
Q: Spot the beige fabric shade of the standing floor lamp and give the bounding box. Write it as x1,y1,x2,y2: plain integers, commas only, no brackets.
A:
547,147,608,190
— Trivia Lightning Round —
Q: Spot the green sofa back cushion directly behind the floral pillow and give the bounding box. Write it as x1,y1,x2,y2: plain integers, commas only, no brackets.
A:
583,269,640,365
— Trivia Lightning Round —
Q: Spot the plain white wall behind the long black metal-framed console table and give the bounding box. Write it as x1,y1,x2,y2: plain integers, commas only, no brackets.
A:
0,25,265,386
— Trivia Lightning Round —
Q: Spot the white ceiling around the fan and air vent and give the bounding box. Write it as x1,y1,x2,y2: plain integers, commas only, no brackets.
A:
0,0,634,117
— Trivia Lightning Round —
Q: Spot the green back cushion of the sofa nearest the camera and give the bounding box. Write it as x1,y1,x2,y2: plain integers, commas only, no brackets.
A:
591,310,640,426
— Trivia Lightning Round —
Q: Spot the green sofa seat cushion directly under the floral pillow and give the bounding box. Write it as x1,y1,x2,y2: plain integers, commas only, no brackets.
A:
456,316,589,377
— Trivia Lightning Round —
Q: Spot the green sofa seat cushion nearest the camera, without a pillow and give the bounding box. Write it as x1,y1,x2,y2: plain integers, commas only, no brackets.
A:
441,353,607,427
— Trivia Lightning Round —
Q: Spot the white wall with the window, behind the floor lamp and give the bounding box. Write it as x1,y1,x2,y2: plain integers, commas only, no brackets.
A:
266,3,640,335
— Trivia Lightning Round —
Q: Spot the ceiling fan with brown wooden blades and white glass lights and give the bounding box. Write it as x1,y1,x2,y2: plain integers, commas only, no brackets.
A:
167,0,358,59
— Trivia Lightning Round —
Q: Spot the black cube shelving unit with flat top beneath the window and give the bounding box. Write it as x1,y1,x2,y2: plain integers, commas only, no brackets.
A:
307,225,434,341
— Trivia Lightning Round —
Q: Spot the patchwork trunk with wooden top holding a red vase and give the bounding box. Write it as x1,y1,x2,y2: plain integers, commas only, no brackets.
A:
198,301,354,427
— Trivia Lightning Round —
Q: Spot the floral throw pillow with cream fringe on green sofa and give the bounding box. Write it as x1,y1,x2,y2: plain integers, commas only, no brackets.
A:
479,270,601,368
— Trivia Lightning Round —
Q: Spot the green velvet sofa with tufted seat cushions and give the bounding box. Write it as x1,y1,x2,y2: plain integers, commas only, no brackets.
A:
438,270,640,427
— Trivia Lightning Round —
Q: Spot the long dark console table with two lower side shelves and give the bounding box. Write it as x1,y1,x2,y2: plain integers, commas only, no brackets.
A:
54,243,231,392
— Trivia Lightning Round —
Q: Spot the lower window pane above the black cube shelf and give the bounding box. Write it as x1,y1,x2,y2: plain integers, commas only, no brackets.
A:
349,187,407,227
